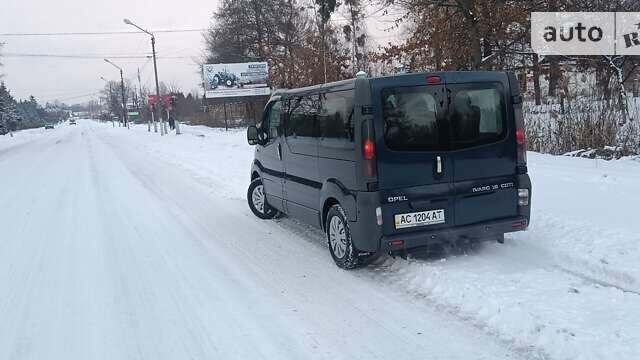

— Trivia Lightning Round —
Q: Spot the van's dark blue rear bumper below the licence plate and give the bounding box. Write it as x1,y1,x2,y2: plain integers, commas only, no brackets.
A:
380,216,529,251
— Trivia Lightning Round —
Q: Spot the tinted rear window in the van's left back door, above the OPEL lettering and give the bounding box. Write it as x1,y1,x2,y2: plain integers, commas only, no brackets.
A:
382,86,446,151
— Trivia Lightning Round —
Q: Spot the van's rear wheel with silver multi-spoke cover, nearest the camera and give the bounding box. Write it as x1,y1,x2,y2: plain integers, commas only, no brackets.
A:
325,204,361,270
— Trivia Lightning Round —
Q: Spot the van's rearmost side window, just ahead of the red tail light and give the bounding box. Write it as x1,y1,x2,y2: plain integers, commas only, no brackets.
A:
318,90,354,145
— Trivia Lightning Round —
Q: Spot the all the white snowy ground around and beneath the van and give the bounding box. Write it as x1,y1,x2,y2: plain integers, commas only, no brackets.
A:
0,121,640,360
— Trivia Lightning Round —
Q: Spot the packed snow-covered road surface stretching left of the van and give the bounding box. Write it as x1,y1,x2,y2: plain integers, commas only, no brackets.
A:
0,121,522,359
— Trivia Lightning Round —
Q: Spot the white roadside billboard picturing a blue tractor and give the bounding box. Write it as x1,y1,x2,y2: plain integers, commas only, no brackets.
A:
202,62,271,98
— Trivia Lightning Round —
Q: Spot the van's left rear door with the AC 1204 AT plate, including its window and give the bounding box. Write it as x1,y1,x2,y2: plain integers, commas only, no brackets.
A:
371,74,455,235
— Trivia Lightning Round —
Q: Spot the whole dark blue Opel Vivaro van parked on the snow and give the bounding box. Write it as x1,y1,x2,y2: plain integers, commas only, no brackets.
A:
247,72,531,269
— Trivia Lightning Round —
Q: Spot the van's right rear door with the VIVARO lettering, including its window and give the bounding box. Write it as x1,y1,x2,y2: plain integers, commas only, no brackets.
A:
447,73,518,225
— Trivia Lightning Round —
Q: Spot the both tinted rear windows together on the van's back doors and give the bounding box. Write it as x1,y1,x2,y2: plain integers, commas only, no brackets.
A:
382,84,506,151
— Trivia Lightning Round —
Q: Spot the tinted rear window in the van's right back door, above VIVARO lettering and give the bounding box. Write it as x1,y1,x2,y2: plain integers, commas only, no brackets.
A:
450,88,506,149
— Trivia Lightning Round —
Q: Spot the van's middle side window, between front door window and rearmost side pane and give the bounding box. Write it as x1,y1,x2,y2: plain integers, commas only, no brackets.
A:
285,95,319,137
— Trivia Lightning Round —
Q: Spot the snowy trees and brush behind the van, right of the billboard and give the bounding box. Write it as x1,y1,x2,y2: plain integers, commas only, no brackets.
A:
203,0,640,153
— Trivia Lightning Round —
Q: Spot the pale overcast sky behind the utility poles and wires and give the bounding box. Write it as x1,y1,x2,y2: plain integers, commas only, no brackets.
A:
0,0,400,103
